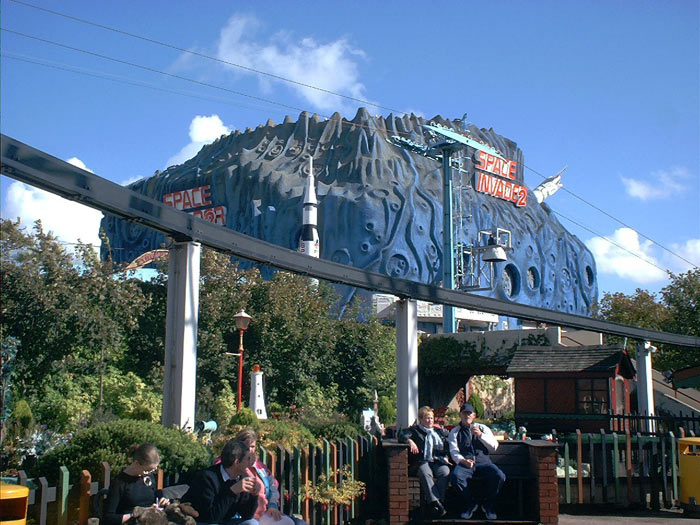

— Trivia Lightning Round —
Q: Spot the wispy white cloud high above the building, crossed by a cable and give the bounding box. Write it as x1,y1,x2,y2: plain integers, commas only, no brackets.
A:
217,15,367,112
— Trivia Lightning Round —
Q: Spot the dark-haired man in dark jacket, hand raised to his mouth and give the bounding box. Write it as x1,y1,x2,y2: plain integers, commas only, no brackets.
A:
182,439,260,525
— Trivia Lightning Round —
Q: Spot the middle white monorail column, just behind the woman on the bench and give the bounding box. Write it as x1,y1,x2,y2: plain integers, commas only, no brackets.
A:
396,299,418,428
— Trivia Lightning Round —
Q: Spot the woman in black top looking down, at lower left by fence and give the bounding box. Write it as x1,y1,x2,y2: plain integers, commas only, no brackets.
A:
104,443,169,525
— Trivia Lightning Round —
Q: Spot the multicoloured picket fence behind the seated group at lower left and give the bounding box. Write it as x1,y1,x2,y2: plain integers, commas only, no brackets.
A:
13,436,386,525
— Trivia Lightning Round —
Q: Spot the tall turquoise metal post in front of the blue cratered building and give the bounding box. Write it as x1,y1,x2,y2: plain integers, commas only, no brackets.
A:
442,148,456,334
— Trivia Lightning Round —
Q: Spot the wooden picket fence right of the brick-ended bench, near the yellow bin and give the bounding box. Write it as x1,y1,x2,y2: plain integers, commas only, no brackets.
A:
558,428,694,510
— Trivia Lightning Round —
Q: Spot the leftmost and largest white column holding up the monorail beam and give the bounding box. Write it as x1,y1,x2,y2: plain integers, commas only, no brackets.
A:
162,241,201,430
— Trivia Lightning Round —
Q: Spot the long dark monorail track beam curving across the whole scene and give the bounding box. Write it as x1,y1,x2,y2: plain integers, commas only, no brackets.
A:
0,135,700,348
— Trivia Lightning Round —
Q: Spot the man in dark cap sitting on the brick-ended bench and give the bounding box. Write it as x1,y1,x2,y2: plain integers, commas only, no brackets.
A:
447,403,506,520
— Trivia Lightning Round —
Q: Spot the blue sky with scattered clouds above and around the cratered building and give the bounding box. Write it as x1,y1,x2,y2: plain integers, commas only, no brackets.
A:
0,0,700,295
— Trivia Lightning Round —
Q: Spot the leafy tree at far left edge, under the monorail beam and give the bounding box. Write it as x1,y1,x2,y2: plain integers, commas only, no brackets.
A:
0,220,148,427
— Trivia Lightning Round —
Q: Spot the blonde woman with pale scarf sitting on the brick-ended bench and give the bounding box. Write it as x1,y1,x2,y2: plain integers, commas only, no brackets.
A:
399,407,450,517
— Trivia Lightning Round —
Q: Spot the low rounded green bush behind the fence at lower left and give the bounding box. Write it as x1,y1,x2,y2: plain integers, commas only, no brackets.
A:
34,419,211,482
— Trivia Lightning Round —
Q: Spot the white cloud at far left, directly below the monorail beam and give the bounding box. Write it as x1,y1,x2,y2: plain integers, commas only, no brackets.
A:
2,179,102,250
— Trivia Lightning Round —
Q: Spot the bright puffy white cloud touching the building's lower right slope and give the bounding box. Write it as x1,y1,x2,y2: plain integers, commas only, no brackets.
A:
586,228,668,285
